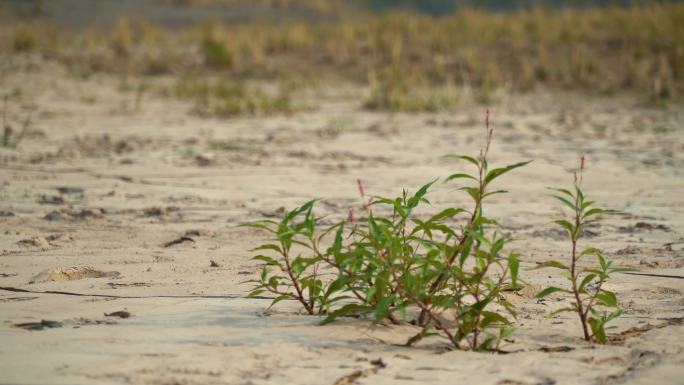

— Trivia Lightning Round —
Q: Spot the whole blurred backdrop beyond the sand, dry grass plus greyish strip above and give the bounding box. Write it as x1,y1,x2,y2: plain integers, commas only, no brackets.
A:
0,0,684,116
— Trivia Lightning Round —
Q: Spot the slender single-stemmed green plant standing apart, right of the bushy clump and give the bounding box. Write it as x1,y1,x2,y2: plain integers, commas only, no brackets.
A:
536,156,633,343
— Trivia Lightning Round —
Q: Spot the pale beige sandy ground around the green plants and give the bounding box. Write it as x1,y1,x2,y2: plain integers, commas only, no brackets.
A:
0,54,684,385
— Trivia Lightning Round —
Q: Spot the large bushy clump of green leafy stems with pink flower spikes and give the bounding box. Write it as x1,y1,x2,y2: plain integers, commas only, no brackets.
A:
244,109,528,350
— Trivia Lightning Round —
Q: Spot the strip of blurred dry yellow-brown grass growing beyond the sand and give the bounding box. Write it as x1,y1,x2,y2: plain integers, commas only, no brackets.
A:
0,4,684,110
